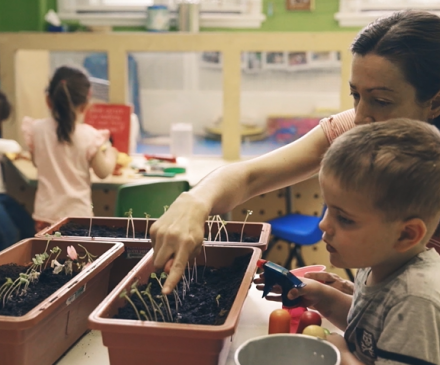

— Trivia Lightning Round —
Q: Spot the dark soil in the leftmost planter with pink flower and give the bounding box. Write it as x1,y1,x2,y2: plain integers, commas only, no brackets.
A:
0,264,77,317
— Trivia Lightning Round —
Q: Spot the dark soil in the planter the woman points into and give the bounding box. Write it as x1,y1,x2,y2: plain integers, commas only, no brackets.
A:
114,254,252,325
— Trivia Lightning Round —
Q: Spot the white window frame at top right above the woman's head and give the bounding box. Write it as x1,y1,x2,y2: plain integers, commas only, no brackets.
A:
335,0,440,27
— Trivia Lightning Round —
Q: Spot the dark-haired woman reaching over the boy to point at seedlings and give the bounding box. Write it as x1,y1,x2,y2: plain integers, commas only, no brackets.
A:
151,11,440,293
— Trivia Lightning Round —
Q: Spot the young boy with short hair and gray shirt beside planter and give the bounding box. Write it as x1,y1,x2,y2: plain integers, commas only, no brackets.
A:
264,119,440,365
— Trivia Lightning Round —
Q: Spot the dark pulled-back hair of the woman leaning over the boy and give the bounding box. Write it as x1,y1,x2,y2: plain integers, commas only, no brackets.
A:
351,10,440,126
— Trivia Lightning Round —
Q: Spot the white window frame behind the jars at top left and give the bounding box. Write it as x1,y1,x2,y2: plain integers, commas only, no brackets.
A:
57,0,265,28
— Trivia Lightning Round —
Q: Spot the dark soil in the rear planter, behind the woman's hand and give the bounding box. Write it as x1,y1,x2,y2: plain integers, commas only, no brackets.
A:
59,222,260,242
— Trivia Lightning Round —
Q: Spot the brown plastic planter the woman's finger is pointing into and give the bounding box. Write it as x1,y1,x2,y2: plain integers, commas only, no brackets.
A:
89,245,261,365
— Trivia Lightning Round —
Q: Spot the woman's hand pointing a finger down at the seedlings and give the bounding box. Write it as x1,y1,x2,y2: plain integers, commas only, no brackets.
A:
150,192,208,294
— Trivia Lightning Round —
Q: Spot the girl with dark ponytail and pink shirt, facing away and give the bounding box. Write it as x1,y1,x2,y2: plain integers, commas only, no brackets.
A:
22,66,117,232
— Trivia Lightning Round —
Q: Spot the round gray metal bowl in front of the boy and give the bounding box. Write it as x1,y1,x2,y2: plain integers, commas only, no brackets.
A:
234,334,341,365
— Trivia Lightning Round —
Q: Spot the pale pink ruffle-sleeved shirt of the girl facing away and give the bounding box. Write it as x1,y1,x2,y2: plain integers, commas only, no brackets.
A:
22,117,110,223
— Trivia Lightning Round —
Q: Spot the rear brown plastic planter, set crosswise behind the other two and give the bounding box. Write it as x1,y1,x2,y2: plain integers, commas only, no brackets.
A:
36,217,270,290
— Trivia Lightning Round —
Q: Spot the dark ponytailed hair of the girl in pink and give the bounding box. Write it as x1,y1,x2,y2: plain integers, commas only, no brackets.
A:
47,66,90,143
